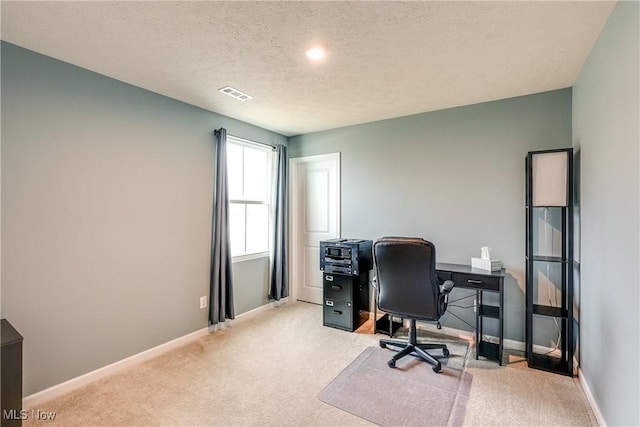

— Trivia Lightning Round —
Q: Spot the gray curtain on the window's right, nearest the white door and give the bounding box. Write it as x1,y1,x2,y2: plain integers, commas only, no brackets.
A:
269,145,289,301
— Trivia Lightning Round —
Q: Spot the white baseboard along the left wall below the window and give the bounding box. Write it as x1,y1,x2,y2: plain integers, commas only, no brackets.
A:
22,298,287,410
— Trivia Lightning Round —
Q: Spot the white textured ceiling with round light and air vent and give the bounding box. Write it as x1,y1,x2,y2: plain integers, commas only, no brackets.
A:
1,1,615,136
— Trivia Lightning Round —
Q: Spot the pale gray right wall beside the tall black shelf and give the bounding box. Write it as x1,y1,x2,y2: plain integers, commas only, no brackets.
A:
573,2,640,426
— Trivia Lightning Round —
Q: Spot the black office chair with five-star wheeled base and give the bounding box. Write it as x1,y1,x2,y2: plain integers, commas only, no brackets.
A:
373,237,453,372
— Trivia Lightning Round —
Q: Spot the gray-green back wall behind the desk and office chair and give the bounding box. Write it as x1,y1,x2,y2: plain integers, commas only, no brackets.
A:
289,89,571,341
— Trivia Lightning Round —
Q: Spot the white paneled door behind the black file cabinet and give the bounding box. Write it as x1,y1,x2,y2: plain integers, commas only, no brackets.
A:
289,153,340,304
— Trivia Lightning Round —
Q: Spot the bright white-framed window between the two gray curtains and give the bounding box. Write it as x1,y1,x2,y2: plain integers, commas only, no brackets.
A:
227,136,273,258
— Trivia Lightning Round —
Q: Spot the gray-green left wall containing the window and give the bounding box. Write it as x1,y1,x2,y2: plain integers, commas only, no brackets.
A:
2,42,286,395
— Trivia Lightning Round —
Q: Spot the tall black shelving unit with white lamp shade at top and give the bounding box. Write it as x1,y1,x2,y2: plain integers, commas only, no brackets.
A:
525,148,574,376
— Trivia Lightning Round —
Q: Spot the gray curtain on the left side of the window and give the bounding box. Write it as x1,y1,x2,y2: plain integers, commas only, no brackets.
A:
209,128,234,325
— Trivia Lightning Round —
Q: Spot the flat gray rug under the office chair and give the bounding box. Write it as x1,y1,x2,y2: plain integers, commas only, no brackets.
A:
318,339,472,426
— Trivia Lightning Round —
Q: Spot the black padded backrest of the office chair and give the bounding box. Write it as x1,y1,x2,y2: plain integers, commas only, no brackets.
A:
373,237,446,320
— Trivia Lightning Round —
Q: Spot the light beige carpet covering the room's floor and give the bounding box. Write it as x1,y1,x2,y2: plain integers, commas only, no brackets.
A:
22,302,597,427
